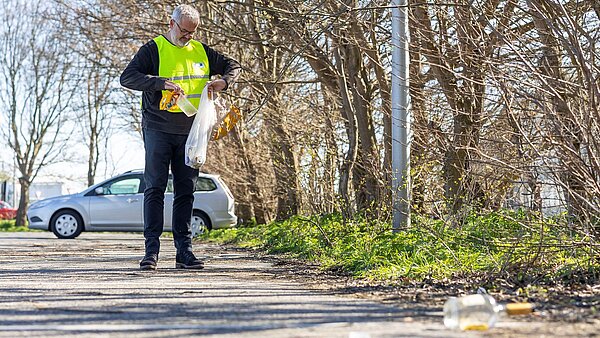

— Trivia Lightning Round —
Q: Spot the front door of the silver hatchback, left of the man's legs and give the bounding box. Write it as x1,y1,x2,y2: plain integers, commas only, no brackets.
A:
89,175,144,230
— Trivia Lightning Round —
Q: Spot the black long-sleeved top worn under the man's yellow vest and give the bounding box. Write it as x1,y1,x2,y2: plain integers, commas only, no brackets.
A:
121,35,241,135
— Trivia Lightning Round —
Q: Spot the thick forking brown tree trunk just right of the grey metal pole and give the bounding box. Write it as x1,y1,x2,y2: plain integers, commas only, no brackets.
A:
413,6,493,213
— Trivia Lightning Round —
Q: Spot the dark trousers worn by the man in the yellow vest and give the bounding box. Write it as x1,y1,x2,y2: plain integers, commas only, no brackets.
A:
143,129,198,254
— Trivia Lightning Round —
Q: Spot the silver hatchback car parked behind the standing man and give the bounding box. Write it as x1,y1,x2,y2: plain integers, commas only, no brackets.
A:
27,170,237,238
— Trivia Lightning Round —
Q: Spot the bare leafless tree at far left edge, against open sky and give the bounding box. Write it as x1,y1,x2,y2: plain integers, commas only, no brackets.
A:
0,0,74,225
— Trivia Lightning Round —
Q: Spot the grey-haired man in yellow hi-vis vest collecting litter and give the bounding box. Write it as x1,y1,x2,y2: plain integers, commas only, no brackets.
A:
121,5,241,270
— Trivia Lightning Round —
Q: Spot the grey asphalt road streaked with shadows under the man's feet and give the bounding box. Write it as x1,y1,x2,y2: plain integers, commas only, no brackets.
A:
0,232,552,338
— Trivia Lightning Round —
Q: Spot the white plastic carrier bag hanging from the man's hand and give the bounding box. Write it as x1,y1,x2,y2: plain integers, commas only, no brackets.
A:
185,87,217,169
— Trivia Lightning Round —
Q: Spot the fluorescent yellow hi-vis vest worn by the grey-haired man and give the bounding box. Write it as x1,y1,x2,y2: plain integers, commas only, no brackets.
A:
154,35,210,113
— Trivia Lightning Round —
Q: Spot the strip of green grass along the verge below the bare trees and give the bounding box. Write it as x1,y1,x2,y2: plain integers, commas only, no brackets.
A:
203,211,600,284
